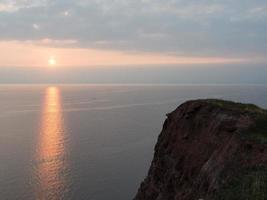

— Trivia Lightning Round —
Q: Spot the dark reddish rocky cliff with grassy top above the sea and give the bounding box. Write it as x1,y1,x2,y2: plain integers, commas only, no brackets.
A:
134,100,267,200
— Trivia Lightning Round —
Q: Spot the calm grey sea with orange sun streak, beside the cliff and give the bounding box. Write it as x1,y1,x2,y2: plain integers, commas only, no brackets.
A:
0,85,267,200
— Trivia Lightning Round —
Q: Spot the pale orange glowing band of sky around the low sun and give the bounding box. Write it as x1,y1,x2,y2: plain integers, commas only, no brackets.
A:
0,40,251,68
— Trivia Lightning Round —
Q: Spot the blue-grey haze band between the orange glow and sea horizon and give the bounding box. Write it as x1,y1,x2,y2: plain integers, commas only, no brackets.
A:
0,64,267,84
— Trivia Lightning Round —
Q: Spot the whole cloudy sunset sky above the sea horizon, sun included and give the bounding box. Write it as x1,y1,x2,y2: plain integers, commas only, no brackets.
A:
0,0,267,83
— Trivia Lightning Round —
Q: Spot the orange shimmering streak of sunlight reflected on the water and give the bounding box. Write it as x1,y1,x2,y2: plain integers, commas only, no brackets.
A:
35,87,68,200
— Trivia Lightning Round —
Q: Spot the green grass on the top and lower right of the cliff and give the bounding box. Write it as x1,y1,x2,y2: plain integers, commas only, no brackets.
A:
192,99,267,200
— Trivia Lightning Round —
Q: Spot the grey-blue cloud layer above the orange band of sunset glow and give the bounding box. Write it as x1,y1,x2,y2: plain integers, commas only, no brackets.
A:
0,0,267,57
